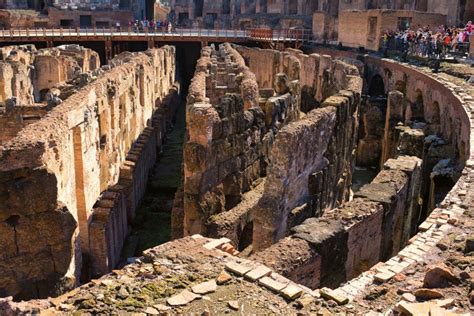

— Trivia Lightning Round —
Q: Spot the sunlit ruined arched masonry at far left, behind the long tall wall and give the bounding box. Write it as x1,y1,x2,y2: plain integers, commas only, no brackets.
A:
0,45,100,144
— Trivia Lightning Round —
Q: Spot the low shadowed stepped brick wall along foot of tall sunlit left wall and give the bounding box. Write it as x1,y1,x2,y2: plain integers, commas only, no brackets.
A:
89,87,180,277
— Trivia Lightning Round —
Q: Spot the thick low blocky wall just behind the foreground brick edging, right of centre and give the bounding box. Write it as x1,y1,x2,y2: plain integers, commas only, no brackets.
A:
252,154,421,288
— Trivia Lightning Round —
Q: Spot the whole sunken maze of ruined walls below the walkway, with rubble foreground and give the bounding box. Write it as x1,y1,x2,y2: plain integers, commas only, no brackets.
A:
0,32,474,314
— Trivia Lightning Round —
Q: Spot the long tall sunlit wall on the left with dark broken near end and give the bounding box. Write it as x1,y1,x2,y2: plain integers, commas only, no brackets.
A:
0,46,177,298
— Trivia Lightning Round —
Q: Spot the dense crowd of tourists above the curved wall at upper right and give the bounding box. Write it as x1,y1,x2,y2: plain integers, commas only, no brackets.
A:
382,21,474,58
